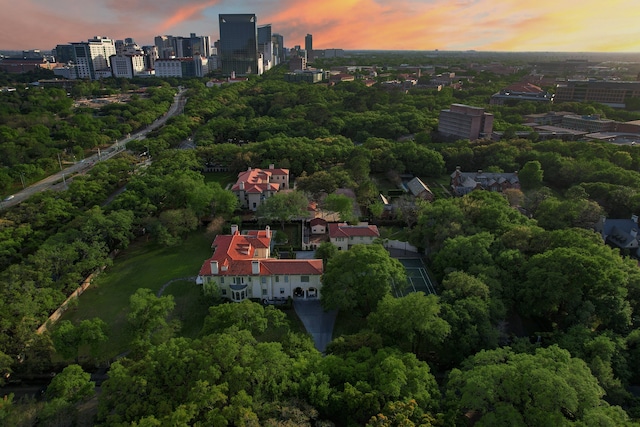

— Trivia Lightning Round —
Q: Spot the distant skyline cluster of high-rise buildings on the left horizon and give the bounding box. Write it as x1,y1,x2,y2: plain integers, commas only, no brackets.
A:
0,13,343,82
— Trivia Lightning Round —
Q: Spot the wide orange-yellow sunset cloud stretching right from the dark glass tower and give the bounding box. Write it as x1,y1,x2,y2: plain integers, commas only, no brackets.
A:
259,0,640,51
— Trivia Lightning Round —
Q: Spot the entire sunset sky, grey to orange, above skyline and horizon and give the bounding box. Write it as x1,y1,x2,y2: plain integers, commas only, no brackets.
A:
0,0,640,52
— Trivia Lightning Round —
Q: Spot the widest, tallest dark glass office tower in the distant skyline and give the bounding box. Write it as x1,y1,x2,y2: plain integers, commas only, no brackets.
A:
218,13,262,76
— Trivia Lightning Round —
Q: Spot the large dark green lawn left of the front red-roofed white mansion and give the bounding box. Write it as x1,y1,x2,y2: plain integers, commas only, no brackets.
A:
62,230,212,359
